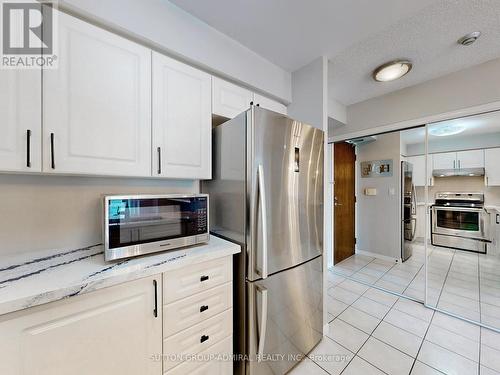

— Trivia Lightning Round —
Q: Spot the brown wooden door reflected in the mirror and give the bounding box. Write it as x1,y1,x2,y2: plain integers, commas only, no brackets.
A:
333,142,356,264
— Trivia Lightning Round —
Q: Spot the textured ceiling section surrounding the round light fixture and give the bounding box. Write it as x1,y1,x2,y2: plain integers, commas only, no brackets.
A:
329,0,500,105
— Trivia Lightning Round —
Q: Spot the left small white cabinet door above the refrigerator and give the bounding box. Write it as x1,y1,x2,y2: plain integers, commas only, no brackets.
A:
212,77,253,118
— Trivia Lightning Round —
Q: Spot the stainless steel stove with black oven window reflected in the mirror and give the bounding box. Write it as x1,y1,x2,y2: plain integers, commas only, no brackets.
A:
431,193,490,253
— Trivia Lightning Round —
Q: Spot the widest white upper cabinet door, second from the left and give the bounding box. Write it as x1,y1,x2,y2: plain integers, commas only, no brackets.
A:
43,13,151,176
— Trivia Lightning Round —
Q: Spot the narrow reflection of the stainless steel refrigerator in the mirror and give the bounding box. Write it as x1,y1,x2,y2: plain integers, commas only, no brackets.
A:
401,161,417,262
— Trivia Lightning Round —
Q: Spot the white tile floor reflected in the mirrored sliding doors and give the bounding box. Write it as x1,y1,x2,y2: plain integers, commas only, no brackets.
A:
333,244,500,329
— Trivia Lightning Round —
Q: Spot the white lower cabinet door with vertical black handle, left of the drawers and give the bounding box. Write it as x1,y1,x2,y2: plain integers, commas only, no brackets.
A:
0,277,162,375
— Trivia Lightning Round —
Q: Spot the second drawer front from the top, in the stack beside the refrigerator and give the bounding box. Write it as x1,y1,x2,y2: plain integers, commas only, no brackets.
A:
163,283,233,337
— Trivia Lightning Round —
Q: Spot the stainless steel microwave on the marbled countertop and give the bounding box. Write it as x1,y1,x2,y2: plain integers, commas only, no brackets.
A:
103,194,209,261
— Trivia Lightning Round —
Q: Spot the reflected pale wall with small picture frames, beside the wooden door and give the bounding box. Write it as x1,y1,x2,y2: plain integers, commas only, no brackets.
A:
356,132,401,259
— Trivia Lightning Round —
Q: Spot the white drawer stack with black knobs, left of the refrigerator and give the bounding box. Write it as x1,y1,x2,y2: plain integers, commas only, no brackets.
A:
163,256,233,375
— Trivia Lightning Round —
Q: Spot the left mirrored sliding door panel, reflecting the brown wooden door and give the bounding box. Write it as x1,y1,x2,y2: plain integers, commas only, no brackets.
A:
331,126,426,302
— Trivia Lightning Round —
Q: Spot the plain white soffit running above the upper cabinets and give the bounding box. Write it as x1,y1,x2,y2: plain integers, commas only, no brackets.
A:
59,0,291,103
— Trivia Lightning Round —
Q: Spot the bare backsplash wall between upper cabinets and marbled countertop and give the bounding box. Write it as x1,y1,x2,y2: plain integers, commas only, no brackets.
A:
0,175,199,256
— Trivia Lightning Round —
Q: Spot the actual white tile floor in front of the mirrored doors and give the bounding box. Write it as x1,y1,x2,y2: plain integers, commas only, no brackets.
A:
291,274,500,375
